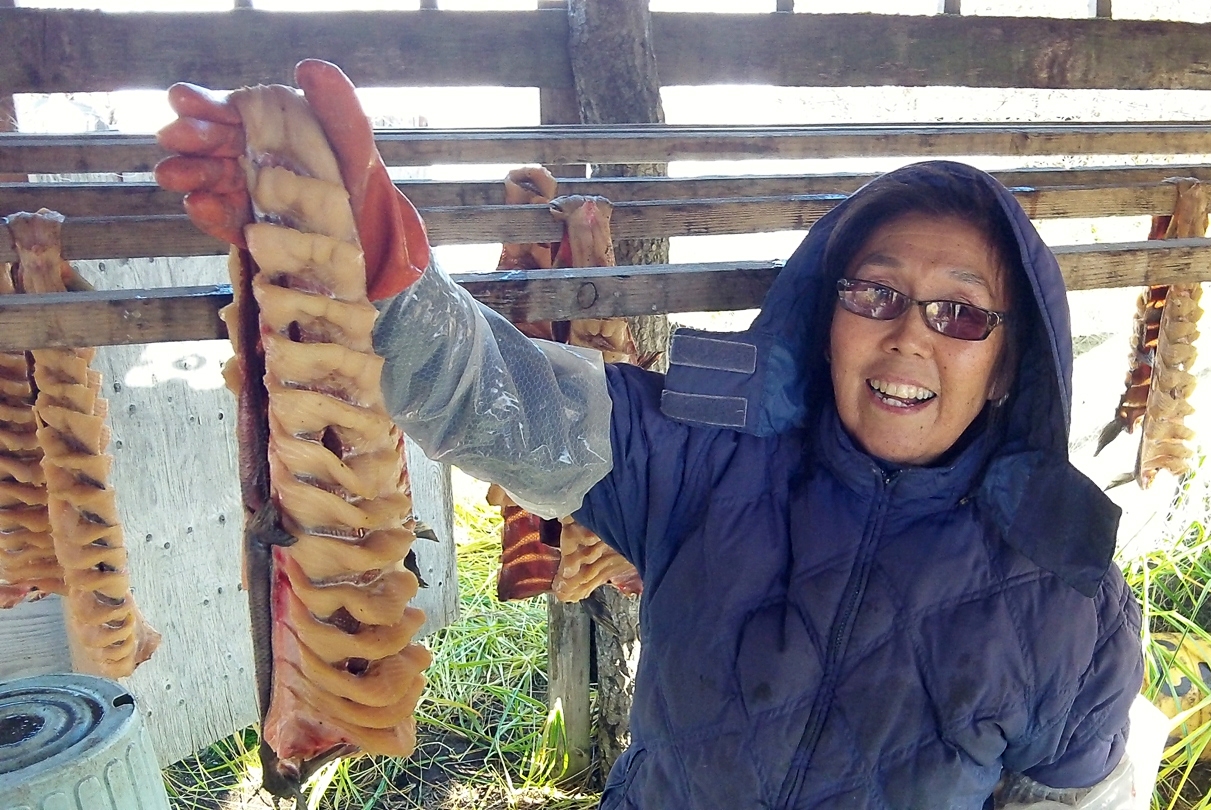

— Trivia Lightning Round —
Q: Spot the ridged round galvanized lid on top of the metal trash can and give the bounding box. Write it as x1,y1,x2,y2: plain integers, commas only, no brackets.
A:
0,674,136,795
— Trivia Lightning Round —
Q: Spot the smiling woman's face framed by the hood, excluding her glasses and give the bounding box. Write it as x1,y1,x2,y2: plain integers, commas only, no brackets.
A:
830,213,1009,465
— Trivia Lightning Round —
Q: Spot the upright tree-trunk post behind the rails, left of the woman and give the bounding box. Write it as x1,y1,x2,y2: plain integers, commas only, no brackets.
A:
568,0,668,779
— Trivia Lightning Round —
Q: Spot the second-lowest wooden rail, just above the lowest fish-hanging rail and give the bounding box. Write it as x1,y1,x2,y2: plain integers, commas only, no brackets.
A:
0,185,1191,262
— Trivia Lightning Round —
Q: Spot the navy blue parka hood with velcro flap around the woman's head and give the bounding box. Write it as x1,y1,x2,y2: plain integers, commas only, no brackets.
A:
661,161,1119,596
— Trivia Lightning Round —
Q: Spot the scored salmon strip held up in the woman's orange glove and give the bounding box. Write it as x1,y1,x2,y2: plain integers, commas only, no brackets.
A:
224,86,430,797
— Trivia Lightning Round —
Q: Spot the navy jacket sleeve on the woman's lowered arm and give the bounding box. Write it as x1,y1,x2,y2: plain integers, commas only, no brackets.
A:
1004,565,1143,788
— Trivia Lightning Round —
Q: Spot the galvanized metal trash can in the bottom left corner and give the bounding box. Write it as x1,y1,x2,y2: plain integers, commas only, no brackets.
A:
0,674,168,810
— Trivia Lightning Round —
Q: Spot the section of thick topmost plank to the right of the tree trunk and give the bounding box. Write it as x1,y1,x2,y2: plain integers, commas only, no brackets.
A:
653,12,1211,90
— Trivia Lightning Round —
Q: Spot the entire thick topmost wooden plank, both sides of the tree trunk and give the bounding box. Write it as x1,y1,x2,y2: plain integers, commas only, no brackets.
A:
7,8,1211,92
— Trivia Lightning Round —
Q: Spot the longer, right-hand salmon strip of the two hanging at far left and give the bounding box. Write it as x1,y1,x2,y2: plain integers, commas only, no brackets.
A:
7,211,160,678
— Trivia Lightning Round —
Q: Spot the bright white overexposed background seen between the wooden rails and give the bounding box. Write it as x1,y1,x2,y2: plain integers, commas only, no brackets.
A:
9,0,1211,535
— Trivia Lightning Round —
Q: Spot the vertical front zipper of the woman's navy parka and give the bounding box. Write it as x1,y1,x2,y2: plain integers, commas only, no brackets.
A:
775,471,895,810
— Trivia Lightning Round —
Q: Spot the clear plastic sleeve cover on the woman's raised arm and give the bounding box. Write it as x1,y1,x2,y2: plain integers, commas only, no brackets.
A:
374,266,612,517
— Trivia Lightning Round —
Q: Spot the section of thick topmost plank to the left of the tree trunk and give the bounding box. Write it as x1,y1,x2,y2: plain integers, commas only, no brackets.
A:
0,8,569,93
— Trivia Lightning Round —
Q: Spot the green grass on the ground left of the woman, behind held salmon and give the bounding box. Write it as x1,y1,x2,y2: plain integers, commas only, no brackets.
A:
165,502,598,810
